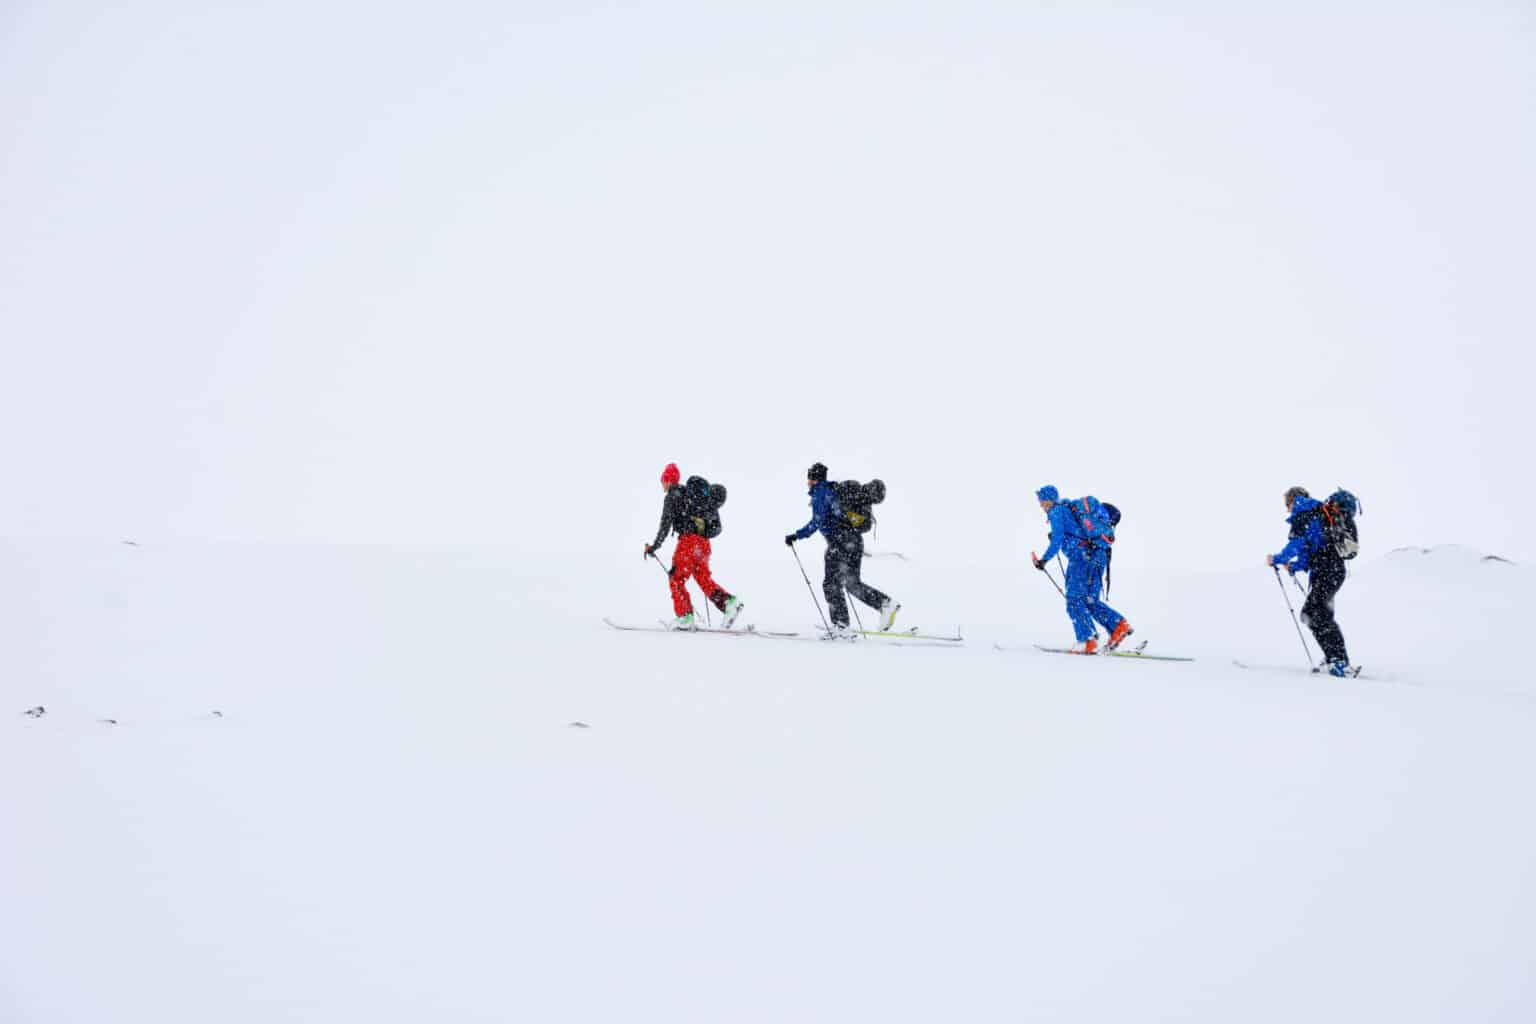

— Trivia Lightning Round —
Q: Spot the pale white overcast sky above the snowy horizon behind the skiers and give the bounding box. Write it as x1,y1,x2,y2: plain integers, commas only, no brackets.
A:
0,0,1536,567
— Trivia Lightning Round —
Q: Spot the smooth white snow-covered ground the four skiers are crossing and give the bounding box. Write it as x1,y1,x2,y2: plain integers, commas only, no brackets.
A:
0,542,1536,1024
